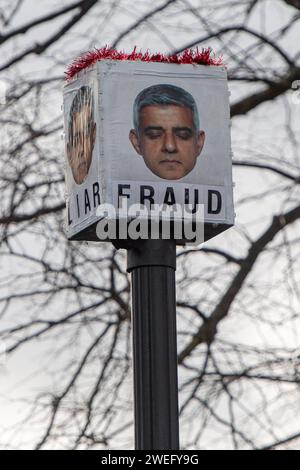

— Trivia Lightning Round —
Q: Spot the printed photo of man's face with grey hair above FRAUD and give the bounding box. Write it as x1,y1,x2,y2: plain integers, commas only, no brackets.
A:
129,85,205,180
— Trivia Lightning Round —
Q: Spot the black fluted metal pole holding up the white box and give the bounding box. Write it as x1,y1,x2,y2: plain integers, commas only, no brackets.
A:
127,240,179,450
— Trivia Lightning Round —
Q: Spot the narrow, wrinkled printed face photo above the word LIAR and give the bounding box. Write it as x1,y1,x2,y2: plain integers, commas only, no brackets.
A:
67,86,96,184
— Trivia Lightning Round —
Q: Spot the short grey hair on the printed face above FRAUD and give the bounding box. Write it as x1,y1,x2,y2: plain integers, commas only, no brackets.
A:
133,84,200,132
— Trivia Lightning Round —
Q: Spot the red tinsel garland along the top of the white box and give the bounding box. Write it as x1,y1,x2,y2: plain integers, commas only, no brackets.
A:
66,46,223,80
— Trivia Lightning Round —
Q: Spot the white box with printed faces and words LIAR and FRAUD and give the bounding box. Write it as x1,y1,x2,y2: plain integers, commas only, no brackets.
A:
64,60,234,241
